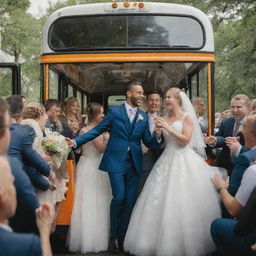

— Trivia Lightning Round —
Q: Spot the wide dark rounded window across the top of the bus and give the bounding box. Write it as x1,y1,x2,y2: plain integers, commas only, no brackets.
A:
48,15,204,51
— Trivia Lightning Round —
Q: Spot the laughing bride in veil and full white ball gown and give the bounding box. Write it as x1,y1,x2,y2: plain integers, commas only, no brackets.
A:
124,88,221,256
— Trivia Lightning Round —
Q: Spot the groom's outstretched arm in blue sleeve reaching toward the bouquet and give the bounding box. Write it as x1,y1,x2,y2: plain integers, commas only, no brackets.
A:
74,108,113,148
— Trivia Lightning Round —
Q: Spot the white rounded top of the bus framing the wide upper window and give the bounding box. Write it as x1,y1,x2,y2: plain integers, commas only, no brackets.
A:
41,2,214,55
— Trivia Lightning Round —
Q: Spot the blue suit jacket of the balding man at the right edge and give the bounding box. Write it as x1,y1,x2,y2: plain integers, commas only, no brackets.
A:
228,147,256,196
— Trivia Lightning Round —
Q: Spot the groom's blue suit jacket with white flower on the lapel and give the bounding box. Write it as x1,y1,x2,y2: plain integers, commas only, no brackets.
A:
75,104,162,174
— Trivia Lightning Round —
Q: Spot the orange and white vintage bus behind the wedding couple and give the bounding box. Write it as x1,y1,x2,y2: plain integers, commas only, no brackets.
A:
40,1,215,246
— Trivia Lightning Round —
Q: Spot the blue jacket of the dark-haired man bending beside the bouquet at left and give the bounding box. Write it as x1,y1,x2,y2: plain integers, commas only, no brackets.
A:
8,124,51,190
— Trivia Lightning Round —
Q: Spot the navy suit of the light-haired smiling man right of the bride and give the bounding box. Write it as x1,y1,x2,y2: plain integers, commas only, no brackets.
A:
215,117,235,175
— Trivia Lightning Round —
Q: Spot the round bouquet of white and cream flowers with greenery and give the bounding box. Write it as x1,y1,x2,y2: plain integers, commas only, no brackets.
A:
42,129,70,168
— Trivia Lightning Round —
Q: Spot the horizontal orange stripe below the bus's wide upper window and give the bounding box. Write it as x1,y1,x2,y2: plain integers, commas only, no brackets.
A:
40,52,215,64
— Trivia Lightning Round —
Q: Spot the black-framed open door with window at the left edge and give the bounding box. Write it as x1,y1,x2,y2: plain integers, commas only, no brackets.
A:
0,62,21,98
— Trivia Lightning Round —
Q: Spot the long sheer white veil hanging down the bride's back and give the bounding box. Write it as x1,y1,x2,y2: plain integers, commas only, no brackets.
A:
179,91,206,158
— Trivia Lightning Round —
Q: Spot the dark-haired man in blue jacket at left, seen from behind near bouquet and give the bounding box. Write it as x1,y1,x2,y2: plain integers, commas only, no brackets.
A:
6,95,51,190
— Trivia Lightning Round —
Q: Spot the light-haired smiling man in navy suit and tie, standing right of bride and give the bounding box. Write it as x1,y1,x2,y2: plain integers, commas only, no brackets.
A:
205,94,250,175
